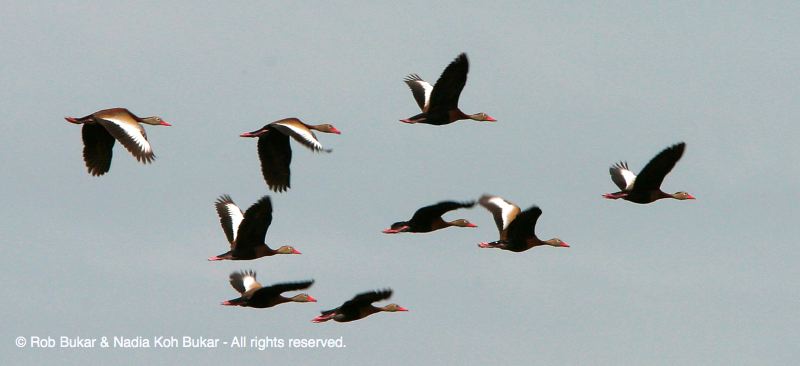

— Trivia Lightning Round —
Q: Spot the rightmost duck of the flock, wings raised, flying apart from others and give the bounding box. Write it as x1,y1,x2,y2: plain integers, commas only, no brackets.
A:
603,142,695,204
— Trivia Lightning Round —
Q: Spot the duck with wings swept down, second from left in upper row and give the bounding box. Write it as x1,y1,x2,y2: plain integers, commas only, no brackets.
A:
241,118,341,192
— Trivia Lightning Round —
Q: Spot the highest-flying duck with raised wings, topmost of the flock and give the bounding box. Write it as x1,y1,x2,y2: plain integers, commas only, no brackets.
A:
400,53,497,126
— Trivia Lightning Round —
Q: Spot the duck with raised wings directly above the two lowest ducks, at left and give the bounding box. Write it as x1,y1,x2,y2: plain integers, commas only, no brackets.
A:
208,194,300,261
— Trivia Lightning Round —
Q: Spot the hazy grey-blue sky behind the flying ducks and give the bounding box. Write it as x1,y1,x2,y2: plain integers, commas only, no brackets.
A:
0,1,800,365
